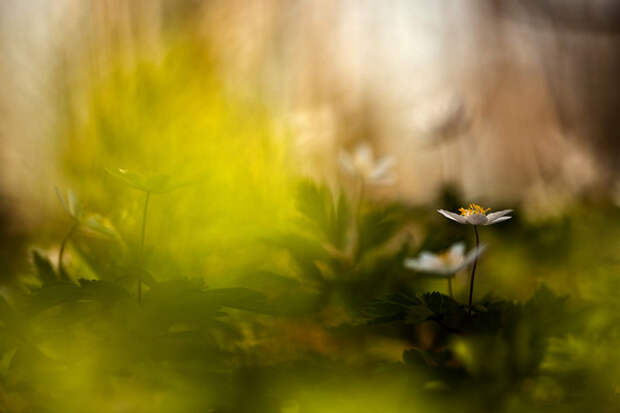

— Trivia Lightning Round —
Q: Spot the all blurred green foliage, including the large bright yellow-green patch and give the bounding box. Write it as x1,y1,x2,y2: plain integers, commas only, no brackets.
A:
0,41,620,413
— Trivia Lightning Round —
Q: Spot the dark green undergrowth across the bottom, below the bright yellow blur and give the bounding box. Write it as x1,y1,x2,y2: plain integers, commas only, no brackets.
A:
0,179,620,412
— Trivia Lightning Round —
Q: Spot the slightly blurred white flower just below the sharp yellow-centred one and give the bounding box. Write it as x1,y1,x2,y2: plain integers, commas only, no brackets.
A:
404,242,486,277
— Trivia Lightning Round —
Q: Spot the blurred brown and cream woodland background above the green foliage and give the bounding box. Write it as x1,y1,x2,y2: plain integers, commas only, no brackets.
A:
0,0,620,229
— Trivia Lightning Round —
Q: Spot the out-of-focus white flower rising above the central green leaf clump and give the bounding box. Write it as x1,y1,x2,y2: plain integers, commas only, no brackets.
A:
339,143,394,184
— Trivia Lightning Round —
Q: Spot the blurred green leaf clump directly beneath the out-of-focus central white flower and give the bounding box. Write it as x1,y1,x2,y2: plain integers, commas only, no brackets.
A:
270,181,414,316
